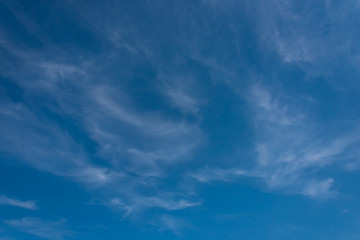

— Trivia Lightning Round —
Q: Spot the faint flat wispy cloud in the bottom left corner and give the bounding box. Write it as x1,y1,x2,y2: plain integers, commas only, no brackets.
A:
4,217,74,240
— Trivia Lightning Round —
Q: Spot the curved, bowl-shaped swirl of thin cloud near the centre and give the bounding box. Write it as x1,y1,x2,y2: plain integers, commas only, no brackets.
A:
84,86,202,175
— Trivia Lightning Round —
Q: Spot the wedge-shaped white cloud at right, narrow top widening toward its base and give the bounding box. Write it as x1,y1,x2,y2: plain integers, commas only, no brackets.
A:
248,85,360,197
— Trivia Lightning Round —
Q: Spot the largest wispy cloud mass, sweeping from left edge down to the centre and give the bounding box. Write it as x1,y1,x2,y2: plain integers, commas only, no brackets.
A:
0,22,202,217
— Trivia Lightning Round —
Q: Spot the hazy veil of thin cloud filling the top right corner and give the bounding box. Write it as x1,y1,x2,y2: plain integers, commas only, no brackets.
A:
254,0,358,71
